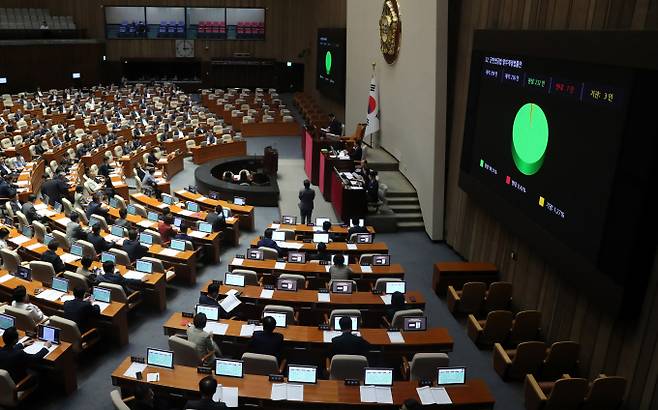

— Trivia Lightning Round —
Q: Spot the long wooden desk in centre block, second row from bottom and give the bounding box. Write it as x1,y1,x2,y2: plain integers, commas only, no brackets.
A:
163,312,454,352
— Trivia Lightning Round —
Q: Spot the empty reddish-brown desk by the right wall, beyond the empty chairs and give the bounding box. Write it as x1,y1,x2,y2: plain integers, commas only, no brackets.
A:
432,262,498,297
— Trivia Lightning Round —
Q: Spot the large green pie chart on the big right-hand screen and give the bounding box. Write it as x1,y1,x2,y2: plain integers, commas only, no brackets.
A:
512,103,548,175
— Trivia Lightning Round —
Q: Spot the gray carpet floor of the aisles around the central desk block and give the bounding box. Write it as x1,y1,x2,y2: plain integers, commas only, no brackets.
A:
29,137,524,410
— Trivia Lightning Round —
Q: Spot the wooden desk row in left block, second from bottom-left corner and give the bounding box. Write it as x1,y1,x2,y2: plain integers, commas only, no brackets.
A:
0,269,128,346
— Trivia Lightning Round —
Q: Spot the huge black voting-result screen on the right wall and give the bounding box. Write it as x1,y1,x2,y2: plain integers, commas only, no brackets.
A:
459,31,658,305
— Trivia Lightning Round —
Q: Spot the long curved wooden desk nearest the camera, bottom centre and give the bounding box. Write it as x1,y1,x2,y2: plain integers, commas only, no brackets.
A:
112,357,495,409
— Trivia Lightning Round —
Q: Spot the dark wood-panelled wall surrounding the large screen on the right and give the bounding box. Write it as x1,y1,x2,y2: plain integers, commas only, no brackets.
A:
446,0,658,409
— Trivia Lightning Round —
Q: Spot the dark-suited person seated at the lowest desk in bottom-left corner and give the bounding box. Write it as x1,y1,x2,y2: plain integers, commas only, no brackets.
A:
0,326,51,388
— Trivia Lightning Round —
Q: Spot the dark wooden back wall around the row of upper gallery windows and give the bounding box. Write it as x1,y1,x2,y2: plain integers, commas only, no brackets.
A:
2,0,346,119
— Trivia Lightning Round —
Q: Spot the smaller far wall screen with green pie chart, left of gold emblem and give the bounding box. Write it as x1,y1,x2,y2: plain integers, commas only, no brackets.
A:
316,29,346,102
